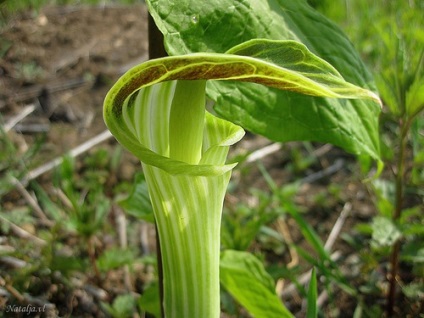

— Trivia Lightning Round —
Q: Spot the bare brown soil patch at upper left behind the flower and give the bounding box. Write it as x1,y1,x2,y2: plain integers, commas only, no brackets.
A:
0,6,147,158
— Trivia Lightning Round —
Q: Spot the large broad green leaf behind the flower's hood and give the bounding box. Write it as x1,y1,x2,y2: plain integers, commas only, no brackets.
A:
147,0,379,158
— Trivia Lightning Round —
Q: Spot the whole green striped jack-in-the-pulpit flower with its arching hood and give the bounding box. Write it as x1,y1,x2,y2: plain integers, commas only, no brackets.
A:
104,40,379,318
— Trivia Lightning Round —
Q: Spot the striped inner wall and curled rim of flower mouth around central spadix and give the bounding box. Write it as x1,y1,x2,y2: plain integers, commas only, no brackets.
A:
106,81,244,176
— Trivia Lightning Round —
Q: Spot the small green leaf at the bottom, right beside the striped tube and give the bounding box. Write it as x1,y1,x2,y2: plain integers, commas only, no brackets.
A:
219,250,293,318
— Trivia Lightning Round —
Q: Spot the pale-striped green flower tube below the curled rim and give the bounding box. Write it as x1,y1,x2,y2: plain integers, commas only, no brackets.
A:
143,165,231,318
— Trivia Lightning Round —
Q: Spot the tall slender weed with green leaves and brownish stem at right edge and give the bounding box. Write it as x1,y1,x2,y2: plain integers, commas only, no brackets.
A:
368,6,424,316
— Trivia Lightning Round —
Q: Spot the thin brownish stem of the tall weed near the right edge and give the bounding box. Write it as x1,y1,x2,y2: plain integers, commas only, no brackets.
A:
386,118,412,317
